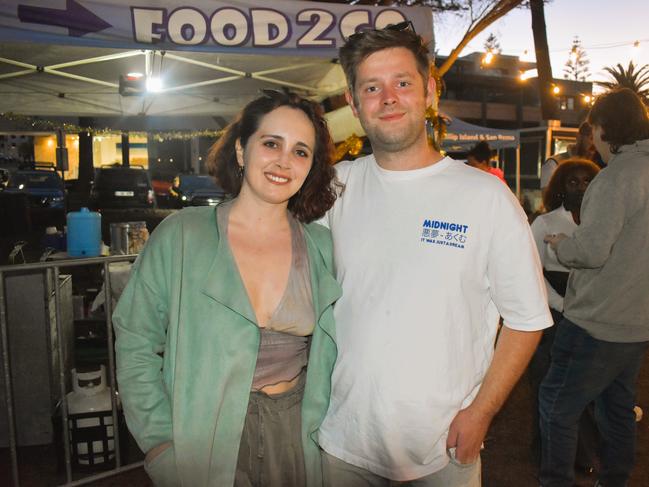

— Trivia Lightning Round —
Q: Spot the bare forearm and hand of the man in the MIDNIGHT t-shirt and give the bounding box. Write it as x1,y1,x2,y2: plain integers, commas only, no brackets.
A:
446,326,543,463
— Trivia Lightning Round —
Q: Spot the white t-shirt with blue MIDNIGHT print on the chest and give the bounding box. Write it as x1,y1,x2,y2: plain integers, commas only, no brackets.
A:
319,156,552,480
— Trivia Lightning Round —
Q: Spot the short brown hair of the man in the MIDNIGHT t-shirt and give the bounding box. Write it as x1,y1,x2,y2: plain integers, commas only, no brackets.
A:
340,23,430,101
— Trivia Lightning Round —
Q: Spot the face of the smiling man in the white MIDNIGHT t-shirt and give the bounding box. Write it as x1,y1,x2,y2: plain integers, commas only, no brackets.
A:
346,47,435,153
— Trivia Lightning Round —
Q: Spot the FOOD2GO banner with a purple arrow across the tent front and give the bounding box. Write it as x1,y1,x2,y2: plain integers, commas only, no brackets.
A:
0,0,433,57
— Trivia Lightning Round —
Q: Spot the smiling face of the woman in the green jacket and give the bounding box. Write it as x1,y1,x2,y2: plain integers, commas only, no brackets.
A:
236,106,316,204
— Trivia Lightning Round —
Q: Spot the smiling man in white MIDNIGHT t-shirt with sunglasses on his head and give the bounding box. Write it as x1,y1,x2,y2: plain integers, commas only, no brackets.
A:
318,25,552,487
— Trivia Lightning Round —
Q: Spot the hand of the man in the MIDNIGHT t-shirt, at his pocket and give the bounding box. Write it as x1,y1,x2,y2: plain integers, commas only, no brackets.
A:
446,406,492,463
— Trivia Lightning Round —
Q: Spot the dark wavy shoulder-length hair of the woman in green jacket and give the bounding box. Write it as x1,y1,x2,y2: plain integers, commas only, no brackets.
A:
207,91,340,223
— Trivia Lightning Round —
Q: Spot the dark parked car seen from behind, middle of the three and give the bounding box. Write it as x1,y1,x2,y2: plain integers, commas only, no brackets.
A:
90,165,155,210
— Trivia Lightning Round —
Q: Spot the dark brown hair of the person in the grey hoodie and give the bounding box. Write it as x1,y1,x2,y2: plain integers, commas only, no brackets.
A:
588,88,649,154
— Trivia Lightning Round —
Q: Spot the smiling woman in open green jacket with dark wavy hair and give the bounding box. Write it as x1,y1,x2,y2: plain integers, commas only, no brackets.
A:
113,92,340,487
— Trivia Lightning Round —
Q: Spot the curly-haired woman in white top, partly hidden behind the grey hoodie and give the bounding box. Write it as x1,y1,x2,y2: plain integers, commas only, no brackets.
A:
529,158,599,471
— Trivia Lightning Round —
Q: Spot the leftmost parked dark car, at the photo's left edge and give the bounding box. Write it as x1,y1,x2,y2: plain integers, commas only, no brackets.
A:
4,166,65,209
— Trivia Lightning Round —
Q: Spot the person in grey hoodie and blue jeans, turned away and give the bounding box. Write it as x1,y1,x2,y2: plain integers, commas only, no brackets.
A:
539,88,649,487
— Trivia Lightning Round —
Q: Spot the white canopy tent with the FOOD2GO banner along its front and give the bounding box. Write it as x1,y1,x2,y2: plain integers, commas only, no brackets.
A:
0,0,432,129
